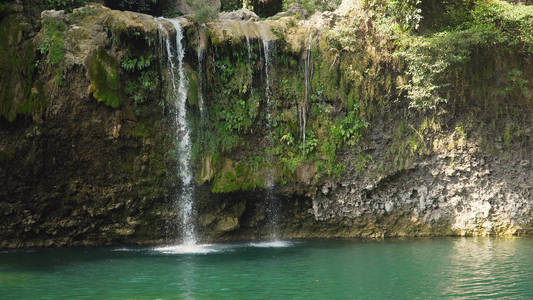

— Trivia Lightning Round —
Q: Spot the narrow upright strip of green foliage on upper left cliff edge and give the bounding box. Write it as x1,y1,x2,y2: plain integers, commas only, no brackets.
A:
39,19,66,86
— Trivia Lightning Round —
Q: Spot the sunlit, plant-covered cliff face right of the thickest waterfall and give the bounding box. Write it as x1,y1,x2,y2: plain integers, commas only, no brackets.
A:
187,1,533,240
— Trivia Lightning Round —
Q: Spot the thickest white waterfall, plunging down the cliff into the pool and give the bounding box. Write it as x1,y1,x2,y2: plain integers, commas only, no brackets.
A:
157,18,196,245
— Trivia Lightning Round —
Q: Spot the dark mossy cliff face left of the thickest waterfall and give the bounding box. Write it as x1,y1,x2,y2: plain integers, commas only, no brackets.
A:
0,6,174,247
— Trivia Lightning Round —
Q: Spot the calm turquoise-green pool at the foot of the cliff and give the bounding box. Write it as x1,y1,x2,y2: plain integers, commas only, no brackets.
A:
0,238,533,299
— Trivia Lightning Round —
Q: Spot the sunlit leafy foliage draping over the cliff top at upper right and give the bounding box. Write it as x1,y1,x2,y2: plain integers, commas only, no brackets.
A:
396,1,533,110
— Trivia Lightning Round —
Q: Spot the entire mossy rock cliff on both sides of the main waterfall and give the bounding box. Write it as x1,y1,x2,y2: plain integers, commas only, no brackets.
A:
0,1,533,247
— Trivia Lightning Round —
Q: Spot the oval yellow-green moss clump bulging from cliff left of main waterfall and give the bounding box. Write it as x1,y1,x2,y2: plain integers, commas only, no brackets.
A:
88,48,120,108
